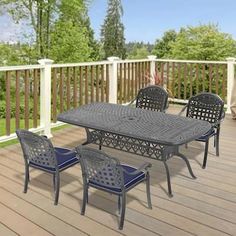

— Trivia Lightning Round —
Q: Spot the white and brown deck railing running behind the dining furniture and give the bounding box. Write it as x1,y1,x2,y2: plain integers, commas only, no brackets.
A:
0,56,235,142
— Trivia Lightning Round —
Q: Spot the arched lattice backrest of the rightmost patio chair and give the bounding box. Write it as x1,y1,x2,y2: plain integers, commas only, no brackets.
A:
186,92,224,124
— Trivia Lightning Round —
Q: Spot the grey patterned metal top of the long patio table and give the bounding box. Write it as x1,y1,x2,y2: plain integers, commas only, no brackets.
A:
57,102,212,145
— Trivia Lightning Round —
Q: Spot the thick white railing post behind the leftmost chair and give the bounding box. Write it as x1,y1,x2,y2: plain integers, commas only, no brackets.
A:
38,59,53,138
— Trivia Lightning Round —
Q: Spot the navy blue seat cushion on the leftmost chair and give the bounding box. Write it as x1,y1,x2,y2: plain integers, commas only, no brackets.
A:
30,147,79,172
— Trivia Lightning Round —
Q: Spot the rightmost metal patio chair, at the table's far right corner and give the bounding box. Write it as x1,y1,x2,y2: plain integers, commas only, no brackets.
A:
180,92,225,169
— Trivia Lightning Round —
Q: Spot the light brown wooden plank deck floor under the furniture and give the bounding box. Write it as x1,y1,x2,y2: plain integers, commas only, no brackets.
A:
0,107,236,236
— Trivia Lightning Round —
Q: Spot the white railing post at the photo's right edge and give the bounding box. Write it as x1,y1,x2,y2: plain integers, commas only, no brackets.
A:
226,57,235,114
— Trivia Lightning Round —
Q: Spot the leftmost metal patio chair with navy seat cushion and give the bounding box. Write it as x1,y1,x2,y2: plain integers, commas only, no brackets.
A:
16,130,79,205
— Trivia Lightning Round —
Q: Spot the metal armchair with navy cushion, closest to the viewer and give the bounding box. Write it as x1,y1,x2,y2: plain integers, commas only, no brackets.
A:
76,146,152,229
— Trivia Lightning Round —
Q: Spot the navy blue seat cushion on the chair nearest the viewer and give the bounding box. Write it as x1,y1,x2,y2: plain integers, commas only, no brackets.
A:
89,164,146,192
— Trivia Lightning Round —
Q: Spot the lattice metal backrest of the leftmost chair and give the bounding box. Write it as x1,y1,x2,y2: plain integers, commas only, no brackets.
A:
16,130,57,168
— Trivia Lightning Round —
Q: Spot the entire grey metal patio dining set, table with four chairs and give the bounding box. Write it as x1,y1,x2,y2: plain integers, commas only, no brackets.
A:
16,86,224,229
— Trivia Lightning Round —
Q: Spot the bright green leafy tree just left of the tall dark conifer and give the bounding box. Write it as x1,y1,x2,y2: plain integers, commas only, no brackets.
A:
50,0,92,62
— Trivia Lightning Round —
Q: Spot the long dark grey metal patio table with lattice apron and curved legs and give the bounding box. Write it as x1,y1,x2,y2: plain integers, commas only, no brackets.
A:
58,103,212,196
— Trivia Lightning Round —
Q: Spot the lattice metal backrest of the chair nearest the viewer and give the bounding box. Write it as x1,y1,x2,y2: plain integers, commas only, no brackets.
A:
76,146,124,189
